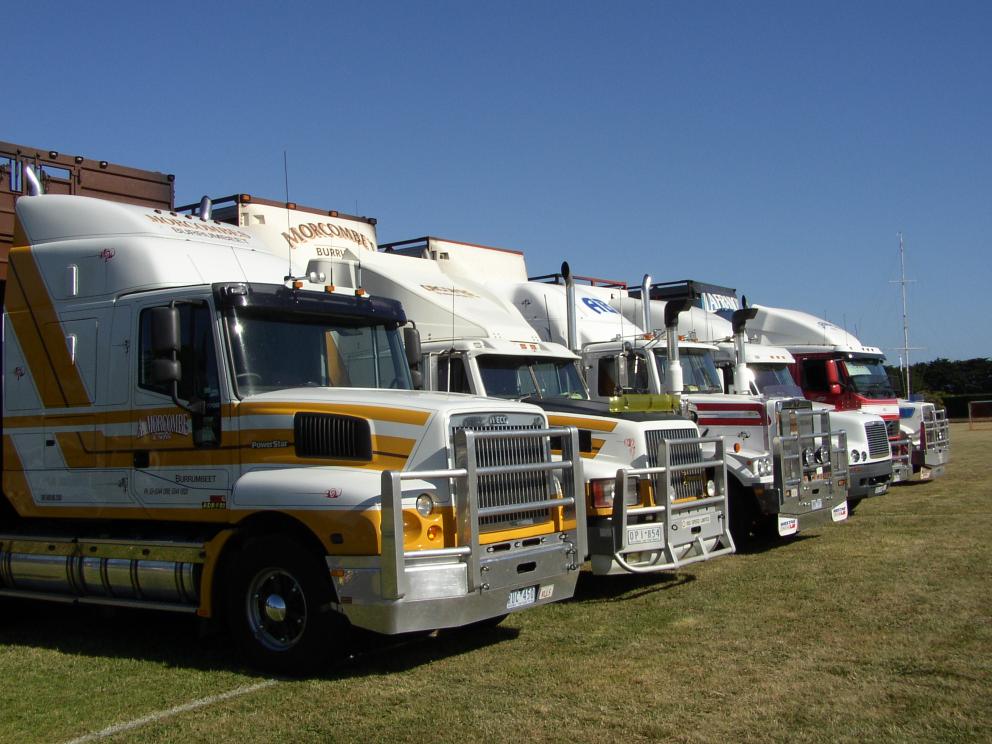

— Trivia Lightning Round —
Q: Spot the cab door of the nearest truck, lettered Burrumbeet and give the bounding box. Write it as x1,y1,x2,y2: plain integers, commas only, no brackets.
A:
131,299,229,510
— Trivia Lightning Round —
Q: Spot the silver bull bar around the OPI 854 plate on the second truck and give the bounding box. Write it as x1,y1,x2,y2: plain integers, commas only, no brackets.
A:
611,437,736,574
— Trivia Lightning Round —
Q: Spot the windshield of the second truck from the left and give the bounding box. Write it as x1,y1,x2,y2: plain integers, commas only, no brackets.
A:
478,354,589,400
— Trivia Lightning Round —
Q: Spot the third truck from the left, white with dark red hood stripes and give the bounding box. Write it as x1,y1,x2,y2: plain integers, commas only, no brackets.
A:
515,271,848,541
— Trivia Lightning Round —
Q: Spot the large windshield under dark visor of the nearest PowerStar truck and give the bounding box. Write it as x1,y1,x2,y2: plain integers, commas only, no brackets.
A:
225,309,413,395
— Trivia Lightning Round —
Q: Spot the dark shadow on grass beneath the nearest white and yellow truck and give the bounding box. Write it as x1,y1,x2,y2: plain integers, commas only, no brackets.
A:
0,599,520,679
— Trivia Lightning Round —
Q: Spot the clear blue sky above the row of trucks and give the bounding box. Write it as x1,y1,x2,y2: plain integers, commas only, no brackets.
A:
9,0,992,362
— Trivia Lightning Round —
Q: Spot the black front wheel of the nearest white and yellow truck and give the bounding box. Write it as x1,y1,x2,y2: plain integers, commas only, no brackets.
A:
226,535,349,676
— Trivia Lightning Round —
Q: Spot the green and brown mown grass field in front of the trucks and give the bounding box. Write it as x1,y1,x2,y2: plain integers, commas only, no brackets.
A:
0,424,992,744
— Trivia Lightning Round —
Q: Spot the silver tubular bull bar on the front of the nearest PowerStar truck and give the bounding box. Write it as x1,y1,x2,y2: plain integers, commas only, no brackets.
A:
380,426,588,600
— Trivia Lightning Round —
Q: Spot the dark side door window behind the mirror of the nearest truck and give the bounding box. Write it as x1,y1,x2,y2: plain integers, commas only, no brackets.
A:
138,303,220,404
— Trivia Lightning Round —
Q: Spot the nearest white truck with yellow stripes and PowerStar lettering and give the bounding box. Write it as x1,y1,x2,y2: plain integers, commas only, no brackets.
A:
0,175,587,673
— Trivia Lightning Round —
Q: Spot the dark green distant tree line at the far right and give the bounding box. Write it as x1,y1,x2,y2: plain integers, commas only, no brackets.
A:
885,357,992,418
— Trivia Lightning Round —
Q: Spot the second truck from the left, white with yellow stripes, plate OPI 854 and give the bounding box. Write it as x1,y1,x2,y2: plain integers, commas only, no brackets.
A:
196,224,734,574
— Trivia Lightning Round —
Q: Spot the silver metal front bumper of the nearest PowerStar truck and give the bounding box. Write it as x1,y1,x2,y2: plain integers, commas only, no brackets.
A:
327,535,581,634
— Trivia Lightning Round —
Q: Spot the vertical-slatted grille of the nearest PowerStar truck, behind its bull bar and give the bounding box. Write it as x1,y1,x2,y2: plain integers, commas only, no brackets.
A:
451,417,554,532
